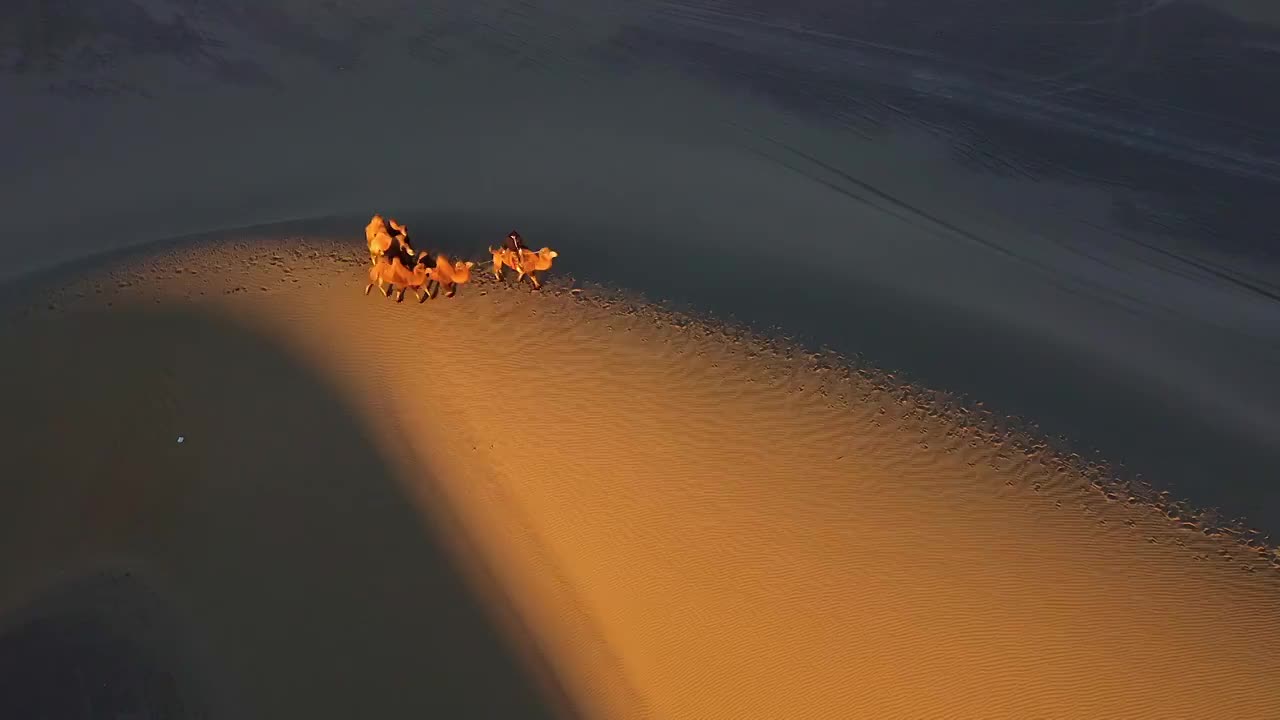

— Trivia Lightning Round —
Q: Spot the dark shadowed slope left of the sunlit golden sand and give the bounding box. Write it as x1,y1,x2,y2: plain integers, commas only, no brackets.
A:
0,299,567,719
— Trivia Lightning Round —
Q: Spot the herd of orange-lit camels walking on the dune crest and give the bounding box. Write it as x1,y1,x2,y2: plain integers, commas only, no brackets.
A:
365,215,559,302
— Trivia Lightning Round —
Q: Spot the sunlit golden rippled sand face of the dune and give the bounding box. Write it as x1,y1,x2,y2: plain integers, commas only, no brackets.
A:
4,236,1280,720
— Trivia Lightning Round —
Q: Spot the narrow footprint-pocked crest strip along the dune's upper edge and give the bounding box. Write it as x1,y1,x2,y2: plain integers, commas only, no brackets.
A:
15,229,1280,568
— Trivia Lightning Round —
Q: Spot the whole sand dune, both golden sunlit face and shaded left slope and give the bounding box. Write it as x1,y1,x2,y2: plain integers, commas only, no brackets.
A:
0,233,1280,719
